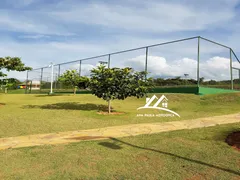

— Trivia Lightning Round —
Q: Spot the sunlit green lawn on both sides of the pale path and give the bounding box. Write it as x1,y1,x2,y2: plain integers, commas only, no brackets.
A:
0,93,240,180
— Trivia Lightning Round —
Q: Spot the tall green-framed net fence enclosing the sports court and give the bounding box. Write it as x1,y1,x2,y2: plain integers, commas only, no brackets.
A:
27,37,240,93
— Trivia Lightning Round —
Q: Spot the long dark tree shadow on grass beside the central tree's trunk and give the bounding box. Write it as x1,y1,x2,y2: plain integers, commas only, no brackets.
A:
23,102,112,111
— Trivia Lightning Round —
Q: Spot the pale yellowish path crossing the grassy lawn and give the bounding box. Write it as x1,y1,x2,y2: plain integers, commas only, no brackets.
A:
0,113,240,150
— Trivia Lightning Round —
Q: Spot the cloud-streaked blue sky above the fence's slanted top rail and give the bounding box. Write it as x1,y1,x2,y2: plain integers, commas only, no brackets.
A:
0,0,240,78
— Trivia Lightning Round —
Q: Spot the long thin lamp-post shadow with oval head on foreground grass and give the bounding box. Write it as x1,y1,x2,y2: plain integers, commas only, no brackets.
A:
98,138,240,175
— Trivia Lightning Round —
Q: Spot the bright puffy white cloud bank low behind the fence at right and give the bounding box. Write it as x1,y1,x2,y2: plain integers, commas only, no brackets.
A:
124,56,240,80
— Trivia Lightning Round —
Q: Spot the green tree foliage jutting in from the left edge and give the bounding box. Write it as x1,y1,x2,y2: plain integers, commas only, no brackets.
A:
0,56,32,77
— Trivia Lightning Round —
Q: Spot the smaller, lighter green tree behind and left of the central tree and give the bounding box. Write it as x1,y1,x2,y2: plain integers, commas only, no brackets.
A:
58,70,89,94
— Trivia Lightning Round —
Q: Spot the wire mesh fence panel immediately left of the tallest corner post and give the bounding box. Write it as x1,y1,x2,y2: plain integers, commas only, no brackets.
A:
147,39,197,87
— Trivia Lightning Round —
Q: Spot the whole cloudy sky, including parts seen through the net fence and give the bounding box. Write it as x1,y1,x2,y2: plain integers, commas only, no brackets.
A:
0,0,240,80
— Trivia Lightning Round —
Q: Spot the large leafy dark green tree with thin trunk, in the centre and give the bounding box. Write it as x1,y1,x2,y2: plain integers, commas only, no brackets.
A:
89,65,152,113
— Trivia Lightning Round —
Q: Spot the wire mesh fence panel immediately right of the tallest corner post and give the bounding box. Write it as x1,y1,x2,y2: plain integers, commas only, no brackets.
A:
199,39,231,89
